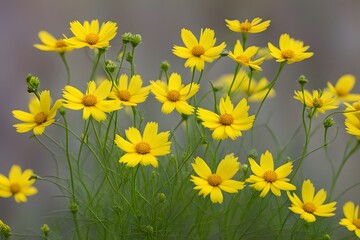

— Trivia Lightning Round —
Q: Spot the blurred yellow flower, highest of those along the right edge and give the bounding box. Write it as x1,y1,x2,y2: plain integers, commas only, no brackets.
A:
327,74,360,102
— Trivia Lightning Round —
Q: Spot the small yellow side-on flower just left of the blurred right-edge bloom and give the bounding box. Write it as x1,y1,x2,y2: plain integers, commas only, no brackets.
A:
294,90,338,114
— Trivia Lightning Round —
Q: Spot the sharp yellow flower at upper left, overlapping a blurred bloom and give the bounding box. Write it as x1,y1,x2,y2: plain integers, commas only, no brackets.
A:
64,19,117,49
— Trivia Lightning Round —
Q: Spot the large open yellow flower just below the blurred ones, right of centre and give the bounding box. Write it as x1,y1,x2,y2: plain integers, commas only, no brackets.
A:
197,96,255,140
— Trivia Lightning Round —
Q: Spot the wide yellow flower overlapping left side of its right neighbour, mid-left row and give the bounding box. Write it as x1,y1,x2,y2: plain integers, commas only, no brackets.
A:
63,80,121,121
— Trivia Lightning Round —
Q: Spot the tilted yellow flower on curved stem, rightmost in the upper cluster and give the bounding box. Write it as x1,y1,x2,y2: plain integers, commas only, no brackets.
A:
268,33,314,64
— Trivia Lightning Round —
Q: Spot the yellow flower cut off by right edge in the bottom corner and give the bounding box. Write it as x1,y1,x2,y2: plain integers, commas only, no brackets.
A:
339,202,360,238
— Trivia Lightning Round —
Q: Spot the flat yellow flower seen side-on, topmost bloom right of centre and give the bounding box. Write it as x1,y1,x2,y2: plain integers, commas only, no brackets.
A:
225,18,271,33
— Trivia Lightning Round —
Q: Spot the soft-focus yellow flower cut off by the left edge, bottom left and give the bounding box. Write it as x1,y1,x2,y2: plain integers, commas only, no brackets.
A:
0,165,37,202
